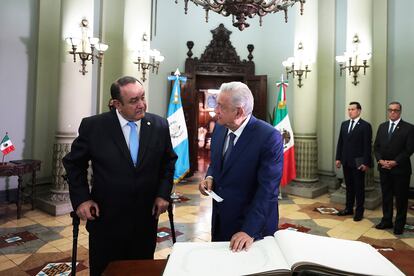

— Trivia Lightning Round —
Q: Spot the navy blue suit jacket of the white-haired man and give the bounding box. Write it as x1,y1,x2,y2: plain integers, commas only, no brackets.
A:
207,116,283,240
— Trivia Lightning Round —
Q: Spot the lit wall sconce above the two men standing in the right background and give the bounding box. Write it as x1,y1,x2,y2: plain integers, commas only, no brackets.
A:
336,34,371,86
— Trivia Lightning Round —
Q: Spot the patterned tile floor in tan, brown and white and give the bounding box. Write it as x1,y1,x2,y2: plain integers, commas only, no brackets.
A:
0,174,414,275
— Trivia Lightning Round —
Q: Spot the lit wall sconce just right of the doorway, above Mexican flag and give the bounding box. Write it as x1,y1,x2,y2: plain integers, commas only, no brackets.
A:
282,42,311,88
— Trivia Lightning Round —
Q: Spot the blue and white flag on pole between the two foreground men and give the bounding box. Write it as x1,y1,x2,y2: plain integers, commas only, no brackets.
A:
167,69,190,184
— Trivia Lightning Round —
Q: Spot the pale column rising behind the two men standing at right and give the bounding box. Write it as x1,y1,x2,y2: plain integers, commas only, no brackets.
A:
331,0,380,209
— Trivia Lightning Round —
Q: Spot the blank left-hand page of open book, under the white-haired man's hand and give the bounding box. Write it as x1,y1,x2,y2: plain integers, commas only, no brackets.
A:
163,237,290,276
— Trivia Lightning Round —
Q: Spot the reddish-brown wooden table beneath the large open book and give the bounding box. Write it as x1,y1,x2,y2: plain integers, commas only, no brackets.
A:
102,250,414,276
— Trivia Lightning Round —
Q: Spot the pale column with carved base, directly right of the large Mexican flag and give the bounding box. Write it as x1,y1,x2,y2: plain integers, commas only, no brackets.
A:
286,0,327,198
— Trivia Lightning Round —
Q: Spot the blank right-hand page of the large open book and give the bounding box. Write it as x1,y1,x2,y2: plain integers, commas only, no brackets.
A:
275,230,404,276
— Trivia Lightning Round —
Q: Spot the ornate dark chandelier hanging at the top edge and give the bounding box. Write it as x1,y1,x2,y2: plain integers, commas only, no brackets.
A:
175,0,306,31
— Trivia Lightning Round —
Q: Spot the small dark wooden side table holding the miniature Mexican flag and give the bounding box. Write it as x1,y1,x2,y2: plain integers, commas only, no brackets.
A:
0,159,41,219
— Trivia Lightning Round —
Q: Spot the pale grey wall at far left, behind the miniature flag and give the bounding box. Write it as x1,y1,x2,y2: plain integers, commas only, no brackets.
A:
0,0,38,190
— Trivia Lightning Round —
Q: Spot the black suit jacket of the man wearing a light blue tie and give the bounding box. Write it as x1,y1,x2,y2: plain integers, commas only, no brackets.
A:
63,111,177,233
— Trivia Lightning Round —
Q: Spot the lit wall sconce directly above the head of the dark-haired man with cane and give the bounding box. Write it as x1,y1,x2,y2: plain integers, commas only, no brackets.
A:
134,33,164,81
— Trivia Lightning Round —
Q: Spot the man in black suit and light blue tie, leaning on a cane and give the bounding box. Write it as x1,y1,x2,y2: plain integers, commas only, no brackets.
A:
63,77,177,275
